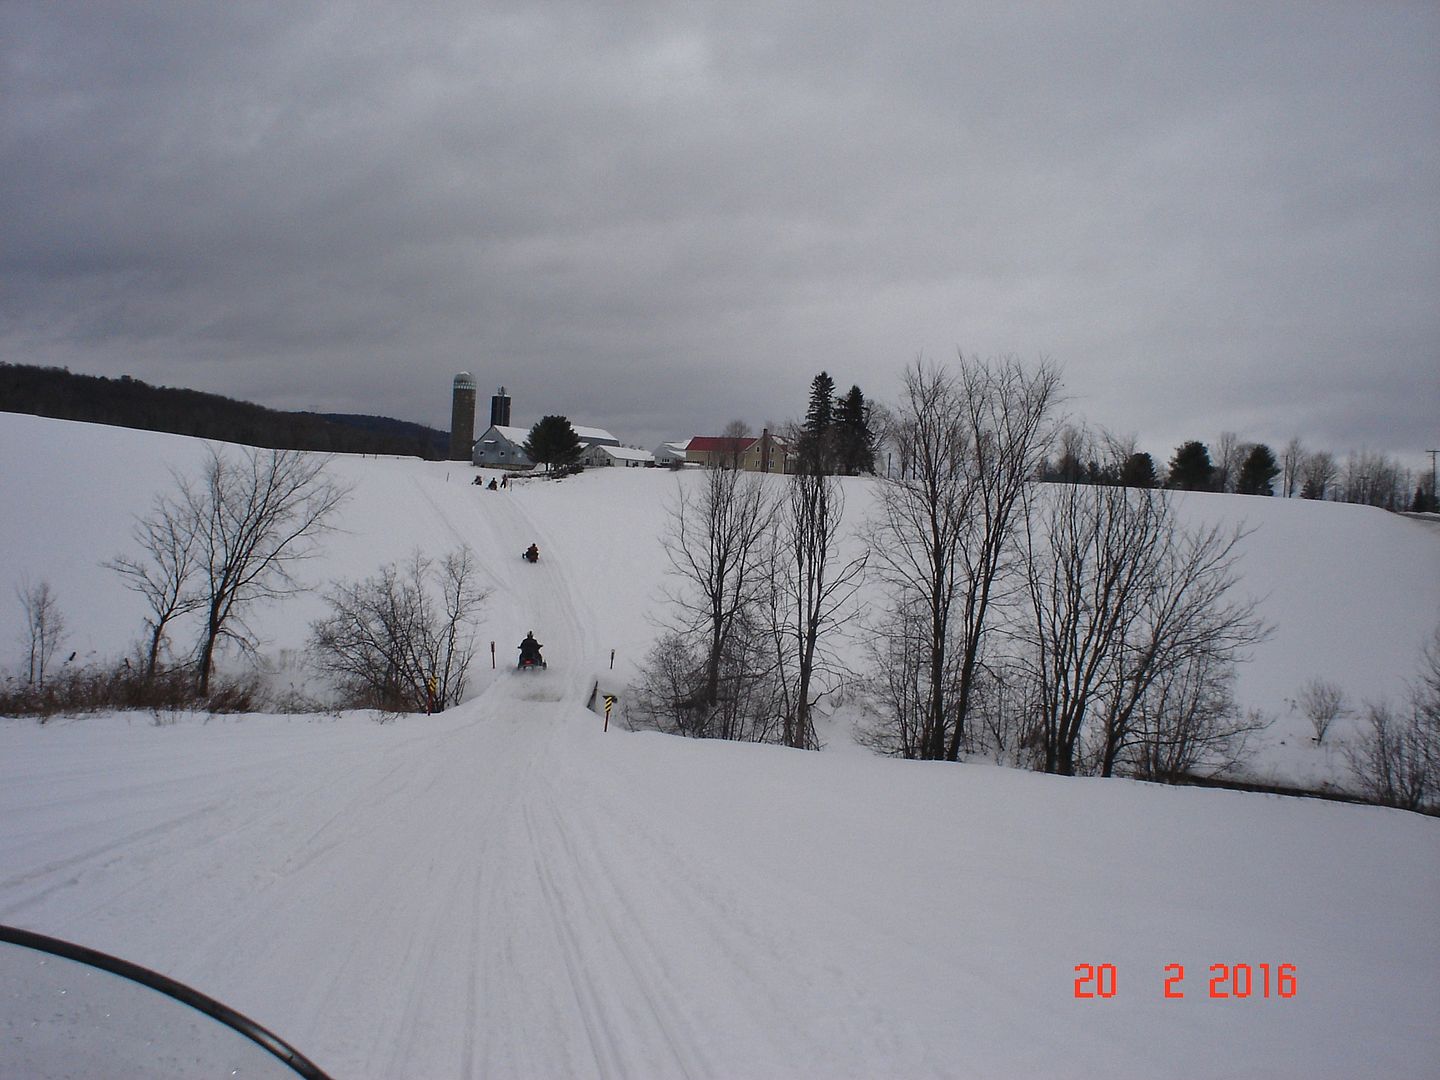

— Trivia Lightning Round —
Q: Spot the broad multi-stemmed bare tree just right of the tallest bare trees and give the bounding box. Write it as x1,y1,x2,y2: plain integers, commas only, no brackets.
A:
1027,469,1267,776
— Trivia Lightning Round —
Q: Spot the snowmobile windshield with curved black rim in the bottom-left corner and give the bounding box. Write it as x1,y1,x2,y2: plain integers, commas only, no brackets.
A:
0,926,327,1080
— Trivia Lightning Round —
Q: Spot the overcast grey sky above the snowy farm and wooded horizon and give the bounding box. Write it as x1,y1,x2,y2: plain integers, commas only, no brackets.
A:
0,0,1440,465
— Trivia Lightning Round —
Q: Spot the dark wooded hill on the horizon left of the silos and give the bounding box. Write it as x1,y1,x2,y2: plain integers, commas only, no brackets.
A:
0,364,449,461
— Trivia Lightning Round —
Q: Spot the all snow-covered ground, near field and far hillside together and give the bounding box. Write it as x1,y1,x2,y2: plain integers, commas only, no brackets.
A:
0,413,1440,1077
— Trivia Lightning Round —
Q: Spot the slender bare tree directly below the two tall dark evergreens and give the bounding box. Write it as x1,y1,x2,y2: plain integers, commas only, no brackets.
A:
769,469,865,749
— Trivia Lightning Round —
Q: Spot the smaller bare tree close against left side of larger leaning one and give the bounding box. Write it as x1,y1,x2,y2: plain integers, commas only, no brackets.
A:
105,497,204,678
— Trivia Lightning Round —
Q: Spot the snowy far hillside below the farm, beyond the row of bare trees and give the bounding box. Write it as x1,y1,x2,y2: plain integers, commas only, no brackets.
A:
0,415,1440,782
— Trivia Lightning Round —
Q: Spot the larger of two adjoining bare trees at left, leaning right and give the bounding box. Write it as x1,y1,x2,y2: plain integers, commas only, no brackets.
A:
181,448,346,694
